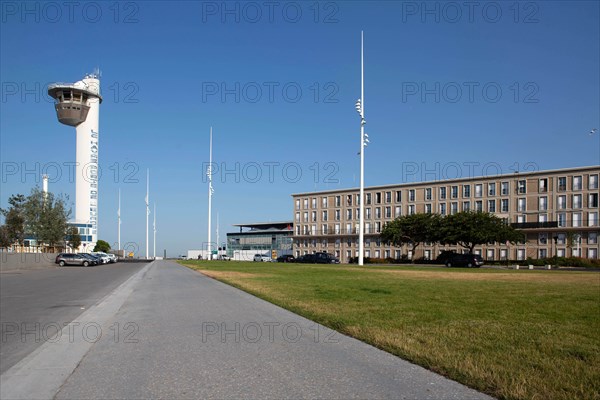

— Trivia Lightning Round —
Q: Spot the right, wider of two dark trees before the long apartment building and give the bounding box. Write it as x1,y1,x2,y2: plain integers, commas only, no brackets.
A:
440,211,525,254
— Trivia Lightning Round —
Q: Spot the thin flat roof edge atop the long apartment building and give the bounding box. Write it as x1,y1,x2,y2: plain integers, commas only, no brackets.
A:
291,165,600,197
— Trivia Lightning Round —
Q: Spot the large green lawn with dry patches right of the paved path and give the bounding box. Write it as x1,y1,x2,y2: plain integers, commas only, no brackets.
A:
182,261,600,400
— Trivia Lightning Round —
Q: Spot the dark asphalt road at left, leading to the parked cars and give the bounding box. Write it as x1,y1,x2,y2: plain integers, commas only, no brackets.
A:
0,263,146,374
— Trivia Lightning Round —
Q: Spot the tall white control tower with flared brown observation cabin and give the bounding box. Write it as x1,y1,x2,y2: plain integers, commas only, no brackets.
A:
48,71,102,251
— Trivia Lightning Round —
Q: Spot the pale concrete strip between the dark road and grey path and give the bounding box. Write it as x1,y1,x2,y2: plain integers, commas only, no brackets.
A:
0,262,154,399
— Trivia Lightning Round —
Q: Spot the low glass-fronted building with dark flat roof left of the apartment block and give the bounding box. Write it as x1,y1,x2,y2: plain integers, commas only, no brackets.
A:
227,221,294,261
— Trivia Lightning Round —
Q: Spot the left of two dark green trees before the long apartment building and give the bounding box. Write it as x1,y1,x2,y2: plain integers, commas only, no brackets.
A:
381,214,441,260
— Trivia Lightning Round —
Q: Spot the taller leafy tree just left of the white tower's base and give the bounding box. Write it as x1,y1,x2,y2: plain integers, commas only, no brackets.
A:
23,187,71,248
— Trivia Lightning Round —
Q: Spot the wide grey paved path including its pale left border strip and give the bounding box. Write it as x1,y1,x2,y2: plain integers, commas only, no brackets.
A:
1,261,489,400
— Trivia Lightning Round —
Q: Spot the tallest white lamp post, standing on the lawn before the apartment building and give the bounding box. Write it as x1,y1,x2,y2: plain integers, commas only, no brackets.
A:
356,31,369,265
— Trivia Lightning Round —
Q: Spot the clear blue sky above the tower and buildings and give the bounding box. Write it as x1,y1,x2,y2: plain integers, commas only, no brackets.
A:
0,1,600,256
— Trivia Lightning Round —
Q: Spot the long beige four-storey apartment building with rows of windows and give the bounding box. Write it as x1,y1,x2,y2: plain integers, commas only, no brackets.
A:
292,166,600,262
